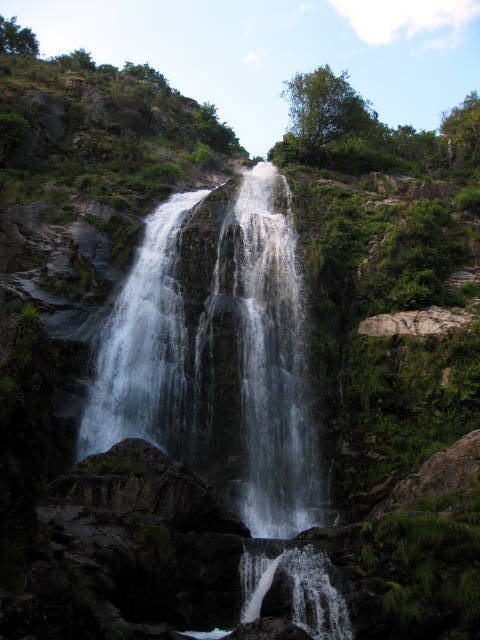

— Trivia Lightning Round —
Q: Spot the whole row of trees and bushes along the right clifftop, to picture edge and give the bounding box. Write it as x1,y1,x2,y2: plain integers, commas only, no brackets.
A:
269,65,480,179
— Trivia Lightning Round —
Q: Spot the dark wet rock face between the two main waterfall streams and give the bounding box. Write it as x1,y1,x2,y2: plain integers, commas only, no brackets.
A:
177,177,242,494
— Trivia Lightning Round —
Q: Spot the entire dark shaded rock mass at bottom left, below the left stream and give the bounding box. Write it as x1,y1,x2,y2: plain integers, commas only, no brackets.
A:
0,440,248,640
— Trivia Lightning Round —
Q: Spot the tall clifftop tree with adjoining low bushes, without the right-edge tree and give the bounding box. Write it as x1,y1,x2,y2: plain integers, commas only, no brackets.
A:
269,65,448,175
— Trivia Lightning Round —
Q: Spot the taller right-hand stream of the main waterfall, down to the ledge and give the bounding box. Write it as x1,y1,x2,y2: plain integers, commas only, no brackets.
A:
196,162,323,538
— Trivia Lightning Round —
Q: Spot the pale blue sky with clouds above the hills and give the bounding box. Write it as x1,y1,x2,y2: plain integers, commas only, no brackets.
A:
0,0,480,156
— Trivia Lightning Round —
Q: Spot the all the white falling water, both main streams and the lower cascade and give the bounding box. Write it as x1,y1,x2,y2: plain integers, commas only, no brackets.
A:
78,168,352,640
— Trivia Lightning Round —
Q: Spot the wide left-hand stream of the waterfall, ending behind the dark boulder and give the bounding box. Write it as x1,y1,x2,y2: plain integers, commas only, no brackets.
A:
78,190,209,458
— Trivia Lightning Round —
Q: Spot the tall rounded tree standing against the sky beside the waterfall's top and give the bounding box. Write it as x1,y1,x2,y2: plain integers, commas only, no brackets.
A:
282,64,377,149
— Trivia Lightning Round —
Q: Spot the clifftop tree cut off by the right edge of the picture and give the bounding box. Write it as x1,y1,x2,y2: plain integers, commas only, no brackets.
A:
441,91,480,167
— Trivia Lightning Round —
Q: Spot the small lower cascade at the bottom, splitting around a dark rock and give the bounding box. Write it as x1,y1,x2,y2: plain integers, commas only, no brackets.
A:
240,545,353,640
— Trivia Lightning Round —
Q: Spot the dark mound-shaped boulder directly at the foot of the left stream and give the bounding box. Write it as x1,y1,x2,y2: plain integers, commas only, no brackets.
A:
52,438,249,537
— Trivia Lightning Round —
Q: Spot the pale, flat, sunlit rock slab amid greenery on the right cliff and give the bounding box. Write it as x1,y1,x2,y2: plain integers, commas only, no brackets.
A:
358,306,475,338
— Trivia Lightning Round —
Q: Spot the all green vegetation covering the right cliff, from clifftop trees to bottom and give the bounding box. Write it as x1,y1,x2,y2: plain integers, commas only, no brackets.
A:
276,66,480,640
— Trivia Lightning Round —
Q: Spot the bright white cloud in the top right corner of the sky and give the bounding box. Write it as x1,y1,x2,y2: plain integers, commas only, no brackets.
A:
328,0,480,45
